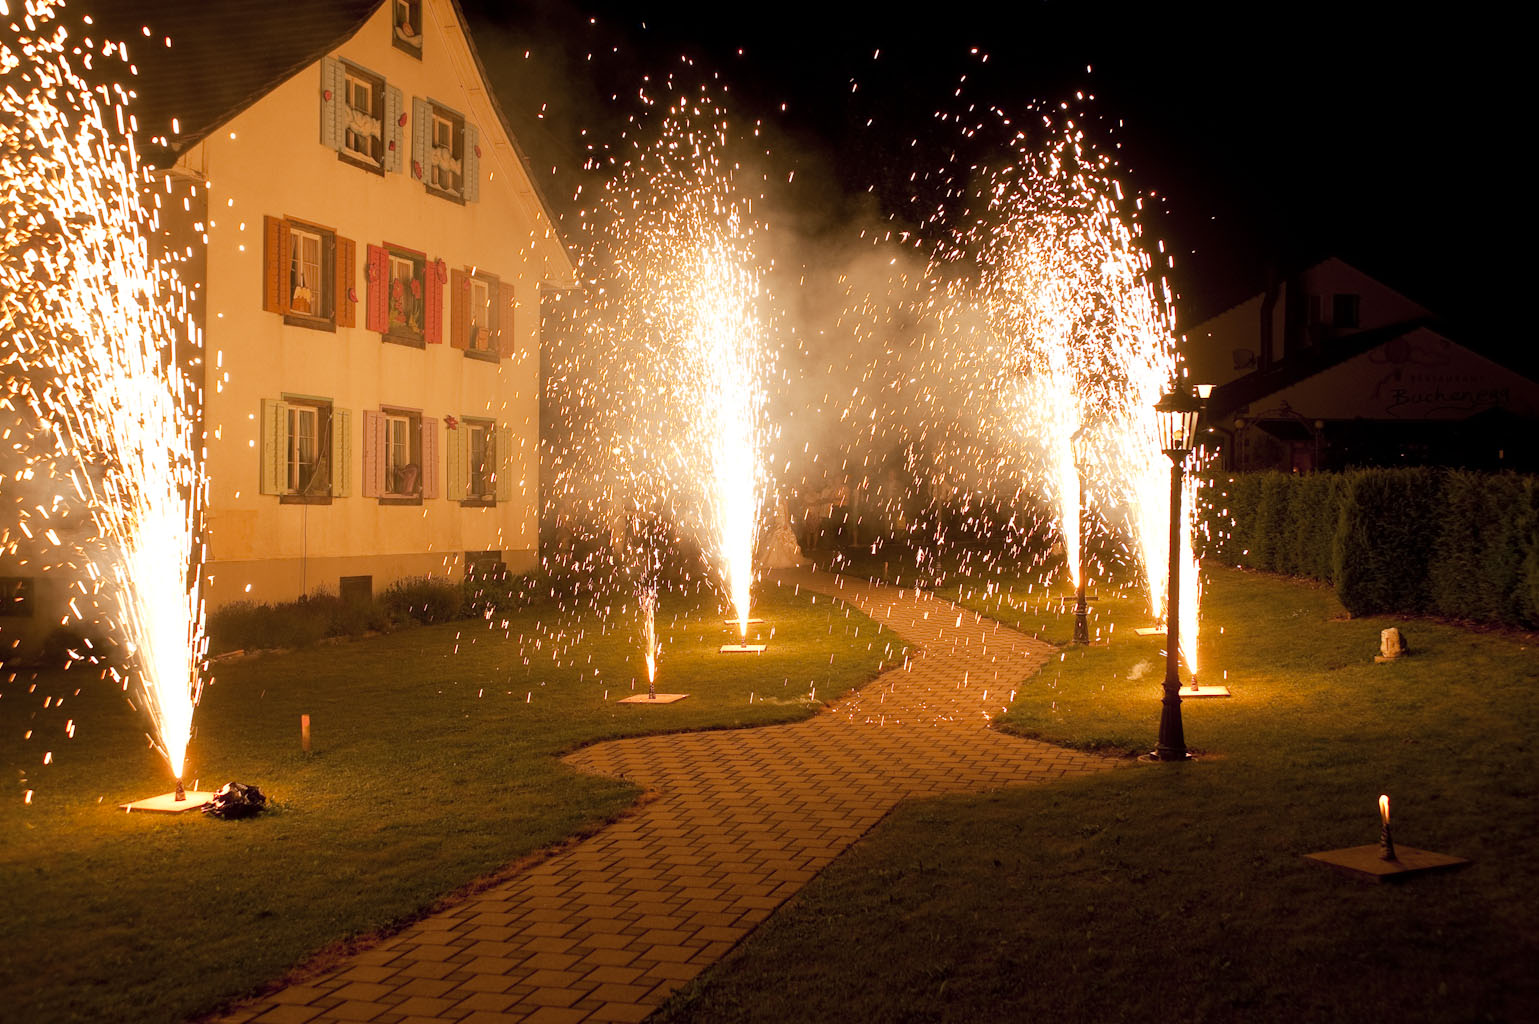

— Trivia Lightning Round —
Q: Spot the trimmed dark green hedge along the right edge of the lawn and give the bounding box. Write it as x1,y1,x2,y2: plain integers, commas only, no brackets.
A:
1203,468,1539,627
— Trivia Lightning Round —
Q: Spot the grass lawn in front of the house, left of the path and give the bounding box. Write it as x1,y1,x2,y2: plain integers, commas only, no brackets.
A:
0,587,880,1022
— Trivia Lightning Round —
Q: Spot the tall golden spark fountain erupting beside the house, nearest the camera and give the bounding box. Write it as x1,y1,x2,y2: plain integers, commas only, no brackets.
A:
0,0,205,802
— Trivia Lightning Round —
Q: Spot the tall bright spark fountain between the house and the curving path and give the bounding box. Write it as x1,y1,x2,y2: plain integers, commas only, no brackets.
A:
572,94,770,655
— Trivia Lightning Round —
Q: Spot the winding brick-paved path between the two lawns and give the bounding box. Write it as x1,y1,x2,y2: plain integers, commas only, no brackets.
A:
228,571,1110,1024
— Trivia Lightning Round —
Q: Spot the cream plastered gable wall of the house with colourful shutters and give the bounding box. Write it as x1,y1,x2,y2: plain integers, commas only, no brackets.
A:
189,0,574,608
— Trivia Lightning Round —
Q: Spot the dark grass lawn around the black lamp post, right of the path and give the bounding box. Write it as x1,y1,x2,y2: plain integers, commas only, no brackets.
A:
659,570,1539,1024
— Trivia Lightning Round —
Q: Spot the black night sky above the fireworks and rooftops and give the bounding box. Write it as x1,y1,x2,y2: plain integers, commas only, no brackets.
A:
463,0,1508,351
